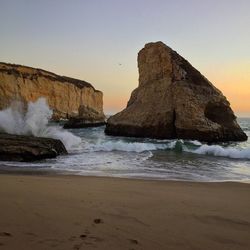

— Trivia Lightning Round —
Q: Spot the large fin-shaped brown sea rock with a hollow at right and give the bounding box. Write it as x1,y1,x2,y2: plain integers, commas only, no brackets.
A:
105,42,247,142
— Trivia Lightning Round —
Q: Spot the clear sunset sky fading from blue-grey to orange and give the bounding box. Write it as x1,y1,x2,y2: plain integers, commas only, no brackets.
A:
0,0,250,116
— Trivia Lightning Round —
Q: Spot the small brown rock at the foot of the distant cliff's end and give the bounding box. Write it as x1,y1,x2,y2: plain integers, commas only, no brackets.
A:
63,105,106,128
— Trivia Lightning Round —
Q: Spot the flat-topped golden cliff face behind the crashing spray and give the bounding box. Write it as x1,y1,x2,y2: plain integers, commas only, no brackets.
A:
0,63,103,120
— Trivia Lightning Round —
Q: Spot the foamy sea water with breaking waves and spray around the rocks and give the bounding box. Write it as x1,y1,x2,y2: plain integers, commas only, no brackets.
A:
0,97,250,182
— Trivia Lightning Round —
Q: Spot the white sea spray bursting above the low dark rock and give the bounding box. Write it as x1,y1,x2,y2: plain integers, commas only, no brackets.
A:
0,98,81,150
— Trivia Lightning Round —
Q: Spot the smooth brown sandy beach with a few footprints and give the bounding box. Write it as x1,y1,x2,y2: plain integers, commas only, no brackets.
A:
0,175,250,250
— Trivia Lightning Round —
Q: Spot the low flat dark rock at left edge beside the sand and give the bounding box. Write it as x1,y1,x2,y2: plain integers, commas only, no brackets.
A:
0,134,67,161
